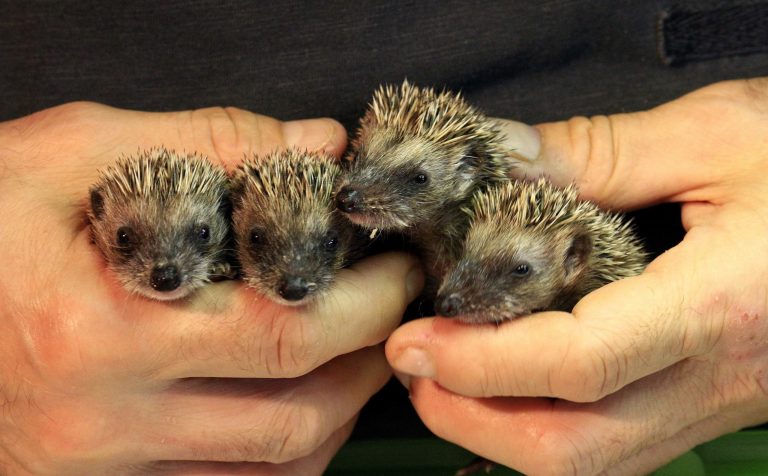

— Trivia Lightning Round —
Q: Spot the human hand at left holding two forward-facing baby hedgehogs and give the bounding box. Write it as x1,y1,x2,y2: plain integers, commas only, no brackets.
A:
0,103,421,475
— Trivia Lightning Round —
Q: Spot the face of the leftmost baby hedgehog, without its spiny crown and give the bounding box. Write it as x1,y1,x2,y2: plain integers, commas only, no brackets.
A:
89,188,229,300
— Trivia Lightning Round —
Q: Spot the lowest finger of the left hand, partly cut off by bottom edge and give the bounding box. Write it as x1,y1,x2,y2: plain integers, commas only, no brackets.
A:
139,420,355,476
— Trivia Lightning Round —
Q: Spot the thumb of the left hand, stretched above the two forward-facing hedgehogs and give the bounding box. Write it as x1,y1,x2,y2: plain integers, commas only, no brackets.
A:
0,103,347,202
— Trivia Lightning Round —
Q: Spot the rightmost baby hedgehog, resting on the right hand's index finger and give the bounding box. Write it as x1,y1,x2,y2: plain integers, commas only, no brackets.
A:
435,179,647,323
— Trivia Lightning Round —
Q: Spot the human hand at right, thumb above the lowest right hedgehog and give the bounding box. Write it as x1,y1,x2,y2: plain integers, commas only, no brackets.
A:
386,79,768,474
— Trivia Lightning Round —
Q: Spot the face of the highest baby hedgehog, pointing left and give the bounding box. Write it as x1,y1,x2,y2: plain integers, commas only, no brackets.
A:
336,129,477,230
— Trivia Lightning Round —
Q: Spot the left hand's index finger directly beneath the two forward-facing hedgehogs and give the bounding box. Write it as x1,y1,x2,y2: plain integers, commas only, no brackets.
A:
104,253,423,382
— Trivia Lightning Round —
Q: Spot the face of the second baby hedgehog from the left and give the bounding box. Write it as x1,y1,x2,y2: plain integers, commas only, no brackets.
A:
233,195,353,306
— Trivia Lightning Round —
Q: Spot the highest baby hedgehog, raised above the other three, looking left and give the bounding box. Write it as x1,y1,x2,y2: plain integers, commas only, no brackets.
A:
336,81,517,275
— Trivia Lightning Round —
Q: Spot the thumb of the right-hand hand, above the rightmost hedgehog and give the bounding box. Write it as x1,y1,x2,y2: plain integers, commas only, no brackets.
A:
492,79,768,209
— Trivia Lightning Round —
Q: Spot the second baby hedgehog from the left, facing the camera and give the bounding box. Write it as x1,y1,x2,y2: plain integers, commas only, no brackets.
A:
233,149,363,305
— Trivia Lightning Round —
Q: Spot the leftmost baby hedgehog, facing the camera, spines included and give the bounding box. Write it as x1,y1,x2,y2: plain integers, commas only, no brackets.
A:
87,148,234,300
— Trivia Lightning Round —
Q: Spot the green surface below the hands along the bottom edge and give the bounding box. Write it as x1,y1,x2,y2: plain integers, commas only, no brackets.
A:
325,430,768,476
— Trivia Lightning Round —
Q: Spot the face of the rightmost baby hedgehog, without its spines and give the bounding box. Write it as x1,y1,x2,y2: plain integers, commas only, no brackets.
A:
435,222,591,324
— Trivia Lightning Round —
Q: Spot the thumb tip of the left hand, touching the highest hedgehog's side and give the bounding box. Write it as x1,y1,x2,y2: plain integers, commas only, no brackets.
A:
282,117,347,157
